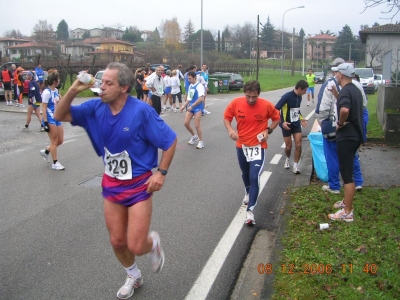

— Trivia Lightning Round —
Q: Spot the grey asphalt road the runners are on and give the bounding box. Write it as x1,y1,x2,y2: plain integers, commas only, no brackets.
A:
0,88,318,300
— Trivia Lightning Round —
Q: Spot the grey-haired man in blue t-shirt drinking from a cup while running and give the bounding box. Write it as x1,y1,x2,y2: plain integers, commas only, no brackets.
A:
54,62,177,299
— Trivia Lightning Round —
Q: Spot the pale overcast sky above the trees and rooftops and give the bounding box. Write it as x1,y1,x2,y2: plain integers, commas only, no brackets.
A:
0,0,400,36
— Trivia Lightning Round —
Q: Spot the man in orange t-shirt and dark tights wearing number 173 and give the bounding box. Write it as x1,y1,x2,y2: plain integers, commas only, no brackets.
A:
224,80,280,225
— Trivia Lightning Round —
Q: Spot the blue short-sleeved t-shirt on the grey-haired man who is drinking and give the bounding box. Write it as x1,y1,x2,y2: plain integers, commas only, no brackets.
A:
71,96,176,177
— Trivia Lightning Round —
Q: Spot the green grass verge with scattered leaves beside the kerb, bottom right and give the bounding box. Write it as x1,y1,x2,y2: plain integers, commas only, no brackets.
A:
272,185,400,300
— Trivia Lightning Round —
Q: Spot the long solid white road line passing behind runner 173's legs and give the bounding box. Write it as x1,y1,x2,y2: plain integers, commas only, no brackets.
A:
185,171,272,300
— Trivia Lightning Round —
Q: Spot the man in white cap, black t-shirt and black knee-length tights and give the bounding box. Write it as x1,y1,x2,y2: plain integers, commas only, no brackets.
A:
328,63,363,222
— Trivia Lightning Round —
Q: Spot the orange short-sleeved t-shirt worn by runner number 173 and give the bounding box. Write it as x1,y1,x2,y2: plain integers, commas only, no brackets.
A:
224,96,280,148
